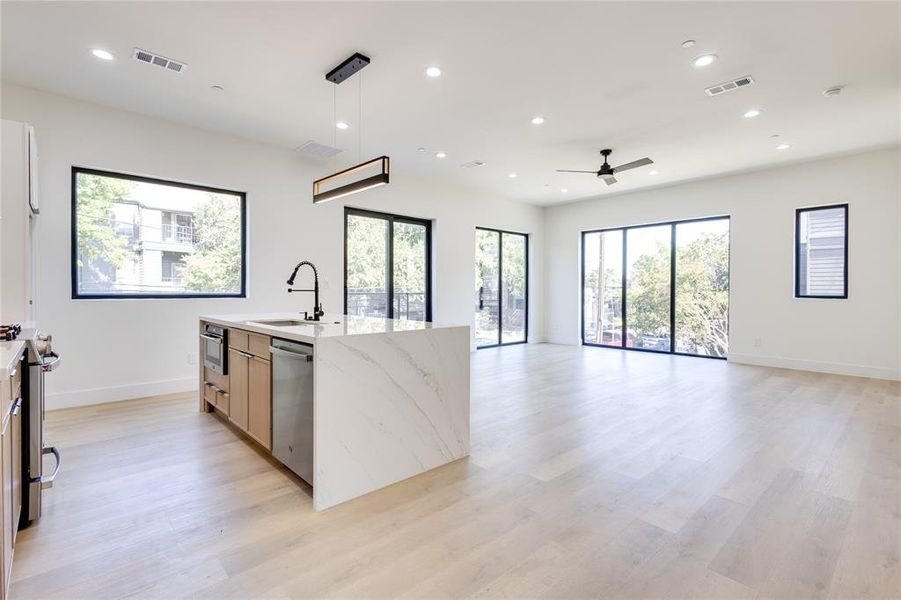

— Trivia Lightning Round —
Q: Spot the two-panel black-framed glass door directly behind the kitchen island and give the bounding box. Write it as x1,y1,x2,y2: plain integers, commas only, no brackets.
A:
344,208,432,321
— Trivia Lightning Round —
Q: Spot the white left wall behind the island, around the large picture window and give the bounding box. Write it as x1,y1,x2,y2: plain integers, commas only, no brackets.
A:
2,83,544,408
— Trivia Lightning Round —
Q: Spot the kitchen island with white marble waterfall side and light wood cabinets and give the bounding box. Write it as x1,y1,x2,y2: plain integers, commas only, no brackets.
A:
200,313,470,511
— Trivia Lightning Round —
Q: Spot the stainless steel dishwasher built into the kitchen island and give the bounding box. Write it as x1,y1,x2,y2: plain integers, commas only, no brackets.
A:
269,338,313,485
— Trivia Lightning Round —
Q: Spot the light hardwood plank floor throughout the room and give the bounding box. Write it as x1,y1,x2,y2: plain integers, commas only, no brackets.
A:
12,345,901,600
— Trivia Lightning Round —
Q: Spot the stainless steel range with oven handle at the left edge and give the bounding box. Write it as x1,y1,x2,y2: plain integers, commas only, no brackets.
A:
20,332,61,527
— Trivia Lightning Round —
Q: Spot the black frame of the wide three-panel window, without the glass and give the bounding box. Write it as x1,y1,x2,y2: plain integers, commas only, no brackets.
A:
579,215,732,360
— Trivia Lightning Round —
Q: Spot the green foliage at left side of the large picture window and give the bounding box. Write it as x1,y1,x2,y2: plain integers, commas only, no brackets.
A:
76,173,132,279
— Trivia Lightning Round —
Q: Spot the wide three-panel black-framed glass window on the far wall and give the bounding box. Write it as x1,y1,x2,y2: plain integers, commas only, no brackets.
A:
581,216,729,358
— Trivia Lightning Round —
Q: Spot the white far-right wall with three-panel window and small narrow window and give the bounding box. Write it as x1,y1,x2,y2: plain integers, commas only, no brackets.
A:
545,148,901,378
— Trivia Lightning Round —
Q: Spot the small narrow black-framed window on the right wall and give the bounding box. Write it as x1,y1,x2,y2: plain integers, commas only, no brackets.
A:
795,204,848,299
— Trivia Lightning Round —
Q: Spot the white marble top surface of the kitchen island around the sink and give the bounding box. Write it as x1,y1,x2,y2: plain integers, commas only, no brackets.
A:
199,312,469,344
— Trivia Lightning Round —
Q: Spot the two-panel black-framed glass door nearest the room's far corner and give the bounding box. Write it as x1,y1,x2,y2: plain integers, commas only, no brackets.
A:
475,227,529,348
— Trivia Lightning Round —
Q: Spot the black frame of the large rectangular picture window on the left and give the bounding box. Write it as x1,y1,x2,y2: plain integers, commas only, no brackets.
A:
69,165,247,300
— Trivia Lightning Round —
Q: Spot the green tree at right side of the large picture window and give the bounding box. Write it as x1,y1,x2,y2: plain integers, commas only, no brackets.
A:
182,194,241,293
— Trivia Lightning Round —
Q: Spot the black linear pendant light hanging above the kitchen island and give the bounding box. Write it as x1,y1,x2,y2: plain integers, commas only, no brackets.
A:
313,52,391,204
